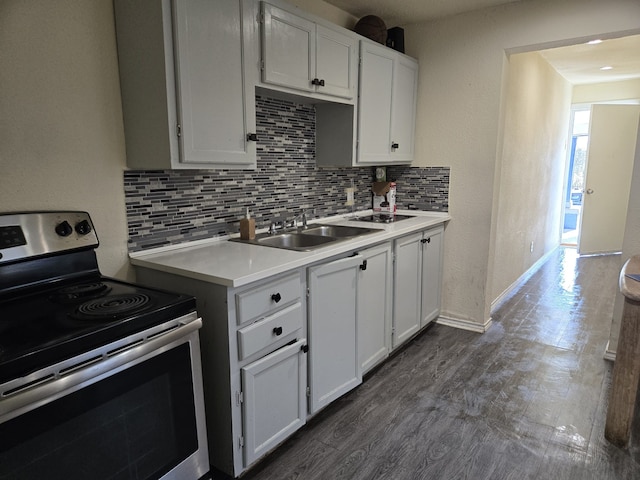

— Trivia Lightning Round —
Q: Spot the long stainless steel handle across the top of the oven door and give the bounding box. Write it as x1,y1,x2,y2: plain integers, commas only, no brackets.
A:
0,318,202,423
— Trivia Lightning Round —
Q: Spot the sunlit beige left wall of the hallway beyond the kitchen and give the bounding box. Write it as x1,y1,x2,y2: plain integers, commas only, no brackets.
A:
490,52,572,299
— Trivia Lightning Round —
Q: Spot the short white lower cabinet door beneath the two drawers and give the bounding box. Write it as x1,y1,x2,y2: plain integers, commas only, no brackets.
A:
242,339,307,467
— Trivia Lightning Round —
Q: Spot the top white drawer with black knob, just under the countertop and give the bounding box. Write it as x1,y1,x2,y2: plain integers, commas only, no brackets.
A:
236,274,301,325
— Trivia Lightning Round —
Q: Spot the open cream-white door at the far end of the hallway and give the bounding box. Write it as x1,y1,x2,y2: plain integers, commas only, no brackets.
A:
578,105,640,255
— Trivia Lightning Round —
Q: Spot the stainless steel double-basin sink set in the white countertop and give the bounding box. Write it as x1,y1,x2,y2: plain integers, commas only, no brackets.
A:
230,223,380,252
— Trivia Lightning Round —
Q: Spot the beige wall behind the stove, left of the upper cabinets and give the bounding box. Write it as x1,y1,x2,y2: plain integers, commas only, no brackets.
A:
0,0,132,279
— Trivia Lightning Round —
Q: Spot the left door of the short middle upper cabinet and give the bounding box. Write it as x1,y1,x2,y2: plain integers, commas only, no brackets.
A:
262,3,316,92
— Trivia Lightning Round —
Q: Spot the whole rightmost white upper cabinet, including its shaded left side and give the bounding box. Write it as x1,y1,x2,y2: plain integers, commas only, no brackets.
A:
316,40,418,167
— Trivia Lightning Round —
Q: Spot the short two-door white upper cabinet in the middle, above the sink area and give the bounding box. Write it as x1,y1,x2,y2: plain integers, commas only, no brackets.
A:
260,2,358,102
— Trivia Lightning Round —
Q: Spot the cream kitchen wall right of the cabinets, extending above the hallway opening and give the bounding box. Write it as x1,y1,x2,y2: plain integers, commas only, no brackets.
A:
405,0,640,328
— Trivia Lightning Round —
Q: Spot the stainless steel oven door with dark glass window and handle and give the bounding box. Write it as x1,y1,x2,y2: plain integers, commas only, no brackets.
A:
0,314,209,480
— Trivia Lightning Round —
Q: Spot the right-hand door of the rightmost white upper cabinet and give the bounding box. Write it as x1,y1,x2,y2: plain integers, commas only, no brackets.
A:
391,55,418,163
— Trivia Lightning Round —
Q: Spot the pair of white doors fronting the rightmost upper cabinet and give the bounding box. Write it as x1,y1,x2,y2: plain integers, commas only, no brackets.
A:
357,41,418,165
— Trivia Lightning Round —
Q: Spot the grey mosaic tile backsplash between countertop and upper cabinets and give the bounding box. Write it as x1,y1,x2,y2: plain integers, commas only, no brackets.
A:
124,97,449,251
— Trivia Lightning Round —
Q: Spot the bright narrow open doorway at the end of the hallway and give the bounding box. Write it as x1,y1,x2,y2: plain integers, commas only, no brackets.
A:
560,105,591,247
